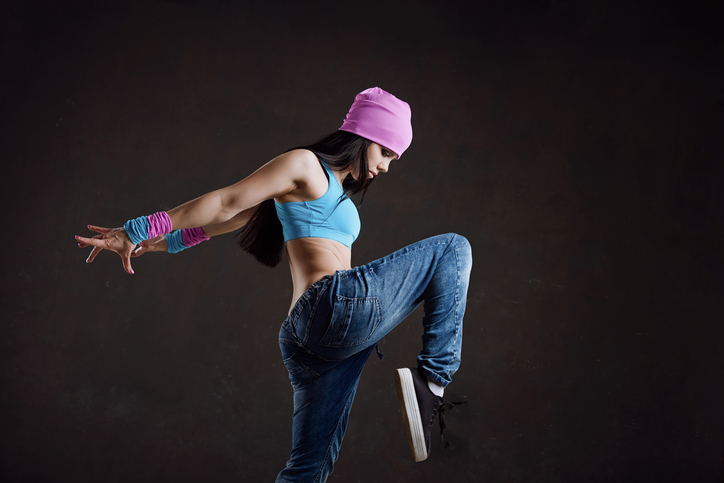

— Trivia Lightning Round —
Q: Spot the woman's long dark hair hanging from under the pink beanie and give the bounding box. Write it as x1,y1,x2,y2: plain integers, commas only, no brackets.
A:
238,131,372,267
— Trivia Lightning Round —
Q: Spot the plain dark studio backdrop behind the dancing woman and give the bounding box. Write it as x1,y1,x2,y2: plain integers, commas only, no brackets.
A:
0,0,724,482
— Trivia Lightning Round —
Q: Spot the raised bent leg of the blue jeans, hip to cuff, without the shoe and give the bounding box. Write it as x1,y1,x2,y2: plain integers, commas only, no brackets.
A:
306,234,472,387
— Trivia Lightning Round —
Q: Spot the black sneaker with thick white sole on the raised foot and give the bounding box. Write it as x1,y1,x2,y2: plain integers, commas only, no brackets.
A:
395,368,444,461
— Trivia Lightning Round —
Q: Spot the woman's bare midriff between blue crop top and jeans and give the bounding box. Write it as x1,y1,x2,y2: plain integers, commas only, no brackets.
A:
286,238,352,312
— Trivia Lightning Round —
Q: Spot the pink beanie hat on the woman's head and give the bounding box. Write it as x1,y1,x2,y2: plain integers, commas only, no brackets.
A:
339,87,412,158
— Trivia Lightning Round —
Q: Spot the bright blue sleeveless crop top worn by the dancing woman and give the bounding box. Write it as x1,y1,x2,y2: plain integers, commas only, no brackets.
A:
274,163,361,248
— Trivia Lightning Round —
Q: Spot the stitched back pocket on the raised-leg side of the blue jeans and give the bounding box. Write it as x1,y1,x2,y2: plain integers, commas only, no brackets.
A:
319,295,382,347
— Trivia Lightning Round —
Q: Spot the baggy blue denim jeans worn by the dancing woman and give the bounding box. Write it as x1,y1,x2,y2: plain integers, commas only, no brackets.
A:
276,234,472,483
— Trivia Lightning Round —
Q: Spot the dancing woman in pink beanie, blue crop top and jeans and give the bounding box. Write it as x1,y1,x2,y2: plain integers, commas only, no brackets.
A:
76,87,472,482
